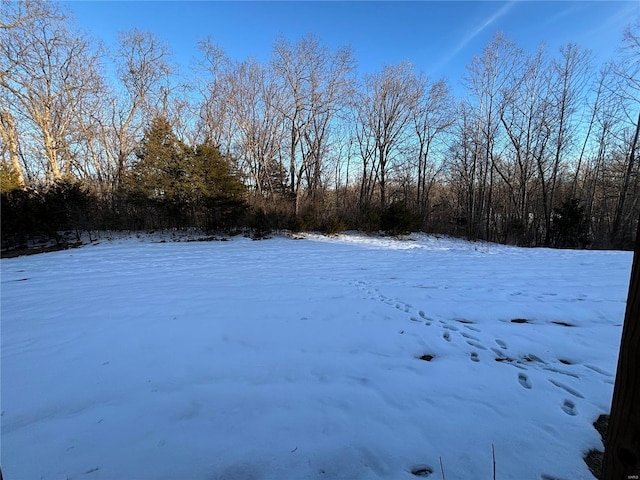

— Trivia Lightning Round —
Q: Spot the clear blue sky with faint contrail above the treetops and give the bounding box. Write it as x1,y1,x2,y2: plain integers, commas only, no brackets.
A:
65,1,640,85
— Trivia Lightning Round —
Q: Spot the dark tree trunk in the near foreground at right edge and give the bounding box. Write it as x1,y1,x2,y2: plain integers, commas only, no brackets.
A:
602,222,640,480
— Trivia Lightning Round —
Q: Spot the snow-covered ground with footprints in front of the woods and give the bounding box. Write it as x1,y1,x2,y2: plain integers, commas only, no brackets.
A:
1,235,632,480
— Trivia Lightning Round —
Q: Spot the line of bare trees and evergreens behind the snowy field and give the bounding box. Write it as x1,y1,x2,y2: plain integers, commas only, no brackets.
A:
0,0,640,248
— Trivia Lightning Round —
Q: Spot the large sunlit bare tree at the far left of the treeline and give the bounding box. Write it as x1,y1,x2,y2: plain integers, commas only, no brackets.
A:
0,3,97,180
